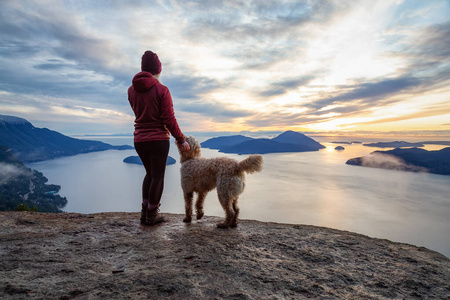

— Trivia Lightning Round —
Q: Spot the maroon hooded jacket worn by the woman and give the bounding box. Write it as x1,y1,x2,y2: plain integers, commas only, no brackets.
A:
128,72,184,143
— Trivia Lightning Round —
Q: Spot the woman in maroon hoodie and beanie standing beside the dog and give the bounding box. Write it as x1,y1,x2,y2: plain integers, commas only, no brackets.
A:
128,51,190,225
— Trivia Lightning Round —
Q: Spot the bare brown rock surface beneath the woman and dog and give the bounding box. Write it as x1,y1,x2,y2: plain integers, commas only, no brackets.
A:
0,212,450,299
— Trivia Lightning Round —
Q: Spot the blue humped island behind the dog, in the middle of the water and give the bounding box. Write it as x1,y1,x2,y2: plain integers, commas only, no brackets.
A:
201,131,325,154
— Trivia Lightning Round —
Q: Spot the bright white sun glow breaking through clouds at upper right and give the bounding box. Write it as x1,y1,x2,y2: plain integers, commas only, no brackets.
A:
305,3,405,86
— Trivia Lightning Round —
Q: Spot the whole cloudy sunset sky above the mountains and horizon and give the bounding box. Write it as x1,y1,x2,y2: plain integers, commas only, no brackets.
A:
0,0,450,134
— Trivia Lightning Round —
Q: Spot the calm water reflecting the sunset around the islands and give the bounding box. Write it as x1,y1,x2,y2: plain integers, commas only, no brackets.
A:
29,138,450,257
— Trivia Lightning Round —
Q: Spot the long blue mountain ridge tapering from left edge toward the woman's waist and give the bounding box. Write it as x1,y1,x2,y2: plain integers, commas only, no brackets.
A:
0,115,133,162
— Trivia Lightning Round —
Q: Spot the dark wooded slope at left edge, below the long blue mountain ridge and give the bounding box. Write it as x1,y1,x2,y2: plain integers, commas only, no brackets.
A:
0,146,67,212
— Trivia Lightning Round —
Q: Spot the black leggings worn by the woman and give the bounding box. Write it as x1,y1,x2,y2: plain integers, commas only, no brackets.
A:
134,140,170,206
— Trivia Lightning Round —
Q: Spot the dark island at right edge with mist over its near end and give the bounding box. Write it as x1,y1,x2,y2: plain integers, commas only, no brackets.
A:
347,147,450,175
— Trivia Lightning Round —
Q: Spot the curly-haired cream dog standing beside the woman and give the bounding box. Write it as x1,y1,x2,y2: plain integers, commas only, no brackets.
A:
178,136,263,228
